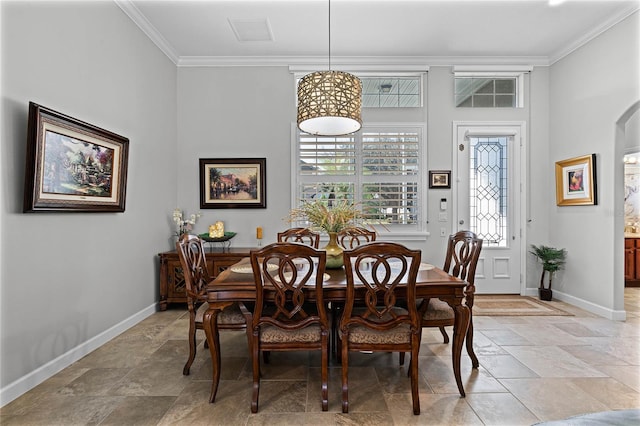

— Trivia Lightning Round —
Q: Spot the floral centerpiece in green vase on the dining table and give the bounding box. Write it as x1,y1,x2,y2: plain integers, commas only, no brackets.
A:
288,200,362,269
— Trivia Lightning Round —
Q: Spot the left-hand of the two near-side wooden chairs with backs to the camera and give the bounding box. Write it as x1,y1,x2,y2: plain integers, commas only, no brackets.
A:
251,243,329,413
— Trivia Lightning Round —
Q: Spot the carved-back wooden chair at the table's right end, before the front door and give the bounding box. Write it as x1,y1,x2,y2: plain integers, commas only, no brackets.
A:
418,231,482,367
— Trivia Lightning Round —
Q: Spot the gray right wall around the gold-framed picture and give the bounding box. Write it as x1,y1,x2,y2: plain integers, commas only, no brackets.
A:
541,12,640,314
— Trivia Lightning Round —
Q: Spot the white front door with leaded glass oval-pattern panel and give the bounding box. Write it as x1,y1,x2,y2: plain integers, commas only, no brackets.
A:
454,123,524,294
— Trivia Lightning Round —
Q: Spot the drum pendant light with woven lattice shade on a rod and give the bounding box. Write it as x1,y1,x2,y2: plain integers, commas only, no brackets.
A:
298,0,362,136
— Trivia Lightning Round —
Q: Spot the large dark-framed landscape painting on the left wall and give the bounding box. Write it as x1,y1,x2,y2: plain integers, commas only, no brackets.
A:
23,102,129,213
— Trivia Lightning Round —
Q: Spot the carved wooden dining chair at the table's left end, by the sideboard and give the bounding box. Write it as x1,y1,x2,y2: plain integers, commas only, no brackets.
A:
176,234,251,376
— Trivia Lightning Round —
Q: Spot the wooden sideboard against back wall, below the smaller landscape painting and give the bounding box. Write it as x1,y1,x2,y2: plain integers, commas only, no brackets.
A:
158,247,252,311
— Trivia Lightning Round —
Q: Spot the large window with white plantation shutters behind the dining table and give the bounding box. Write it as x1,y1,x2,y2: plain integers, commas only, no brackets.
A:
293,124,425,232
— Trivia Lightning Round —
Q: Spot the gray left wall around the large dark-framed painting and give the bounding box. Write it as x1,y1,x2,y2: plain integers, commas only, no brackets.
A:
0,1,177,402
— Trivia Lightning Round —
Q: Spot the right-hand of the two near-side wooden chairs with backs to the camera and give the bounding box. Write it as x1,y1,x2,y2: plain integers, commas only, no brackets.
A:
339,242,421,414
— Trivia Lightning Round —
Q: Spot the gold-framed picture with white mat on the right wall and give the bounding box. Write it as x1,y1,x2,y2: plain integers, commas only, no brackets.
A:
556,154,598,206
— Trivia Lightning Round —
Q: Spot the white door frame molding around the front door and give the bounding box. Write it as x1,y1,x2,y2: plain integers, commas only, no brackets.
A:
451,120,537,296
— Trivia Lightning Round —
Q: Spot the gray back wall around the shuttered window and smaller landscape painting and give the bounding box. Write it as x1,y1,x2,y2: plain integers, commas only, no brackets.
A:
178,66,548,272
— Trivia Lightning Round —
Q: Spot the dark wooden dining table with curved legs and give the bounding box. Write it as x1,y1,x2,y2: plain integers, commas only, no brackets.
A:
203,257,477,402
